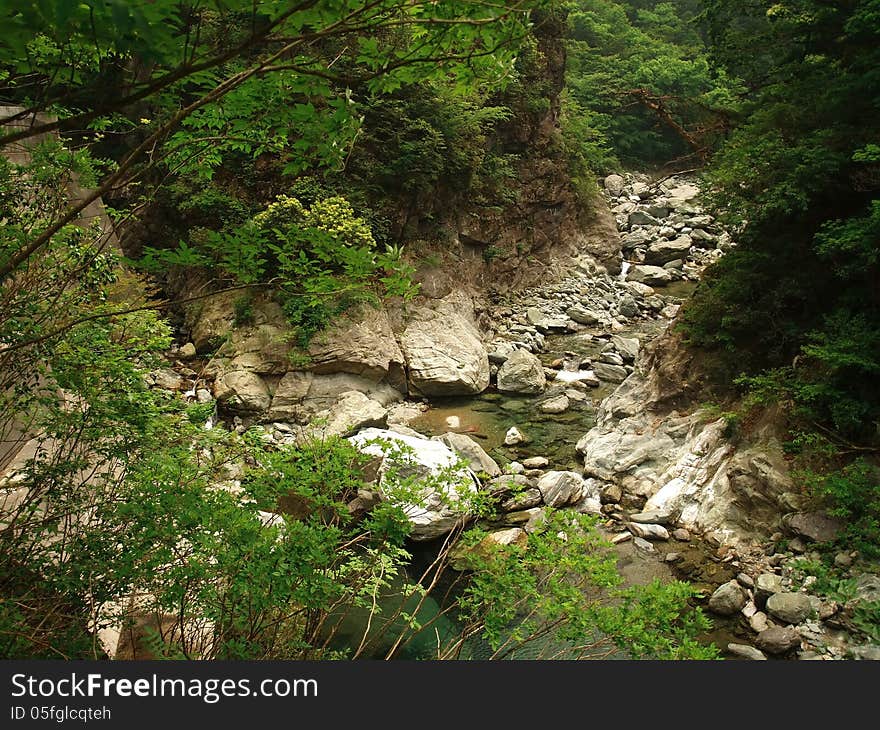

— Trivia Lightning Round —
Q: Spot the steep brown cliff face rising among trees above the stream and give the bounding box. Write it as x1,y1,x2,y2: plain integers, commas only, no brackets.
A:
410,8,620,297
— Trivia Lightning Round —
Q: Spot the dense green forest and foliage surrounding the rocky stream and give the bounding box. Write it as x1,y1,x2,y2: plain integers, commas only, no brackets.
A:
0,0,880,659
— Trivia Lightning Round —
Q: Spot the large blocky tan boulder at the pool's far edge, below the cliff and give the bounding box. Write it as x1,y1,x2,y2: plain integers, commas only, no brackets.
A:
400,300,489,396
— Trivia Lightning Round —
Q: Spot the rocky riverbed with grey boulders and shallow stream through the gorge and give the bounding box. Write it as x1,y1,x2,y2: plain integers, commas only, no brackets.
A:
154,175,880,659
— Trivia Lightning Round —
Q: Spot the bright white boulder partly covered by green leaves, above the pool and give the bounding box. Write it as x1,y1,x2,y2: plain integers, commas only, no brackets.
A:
348,428,479,541
